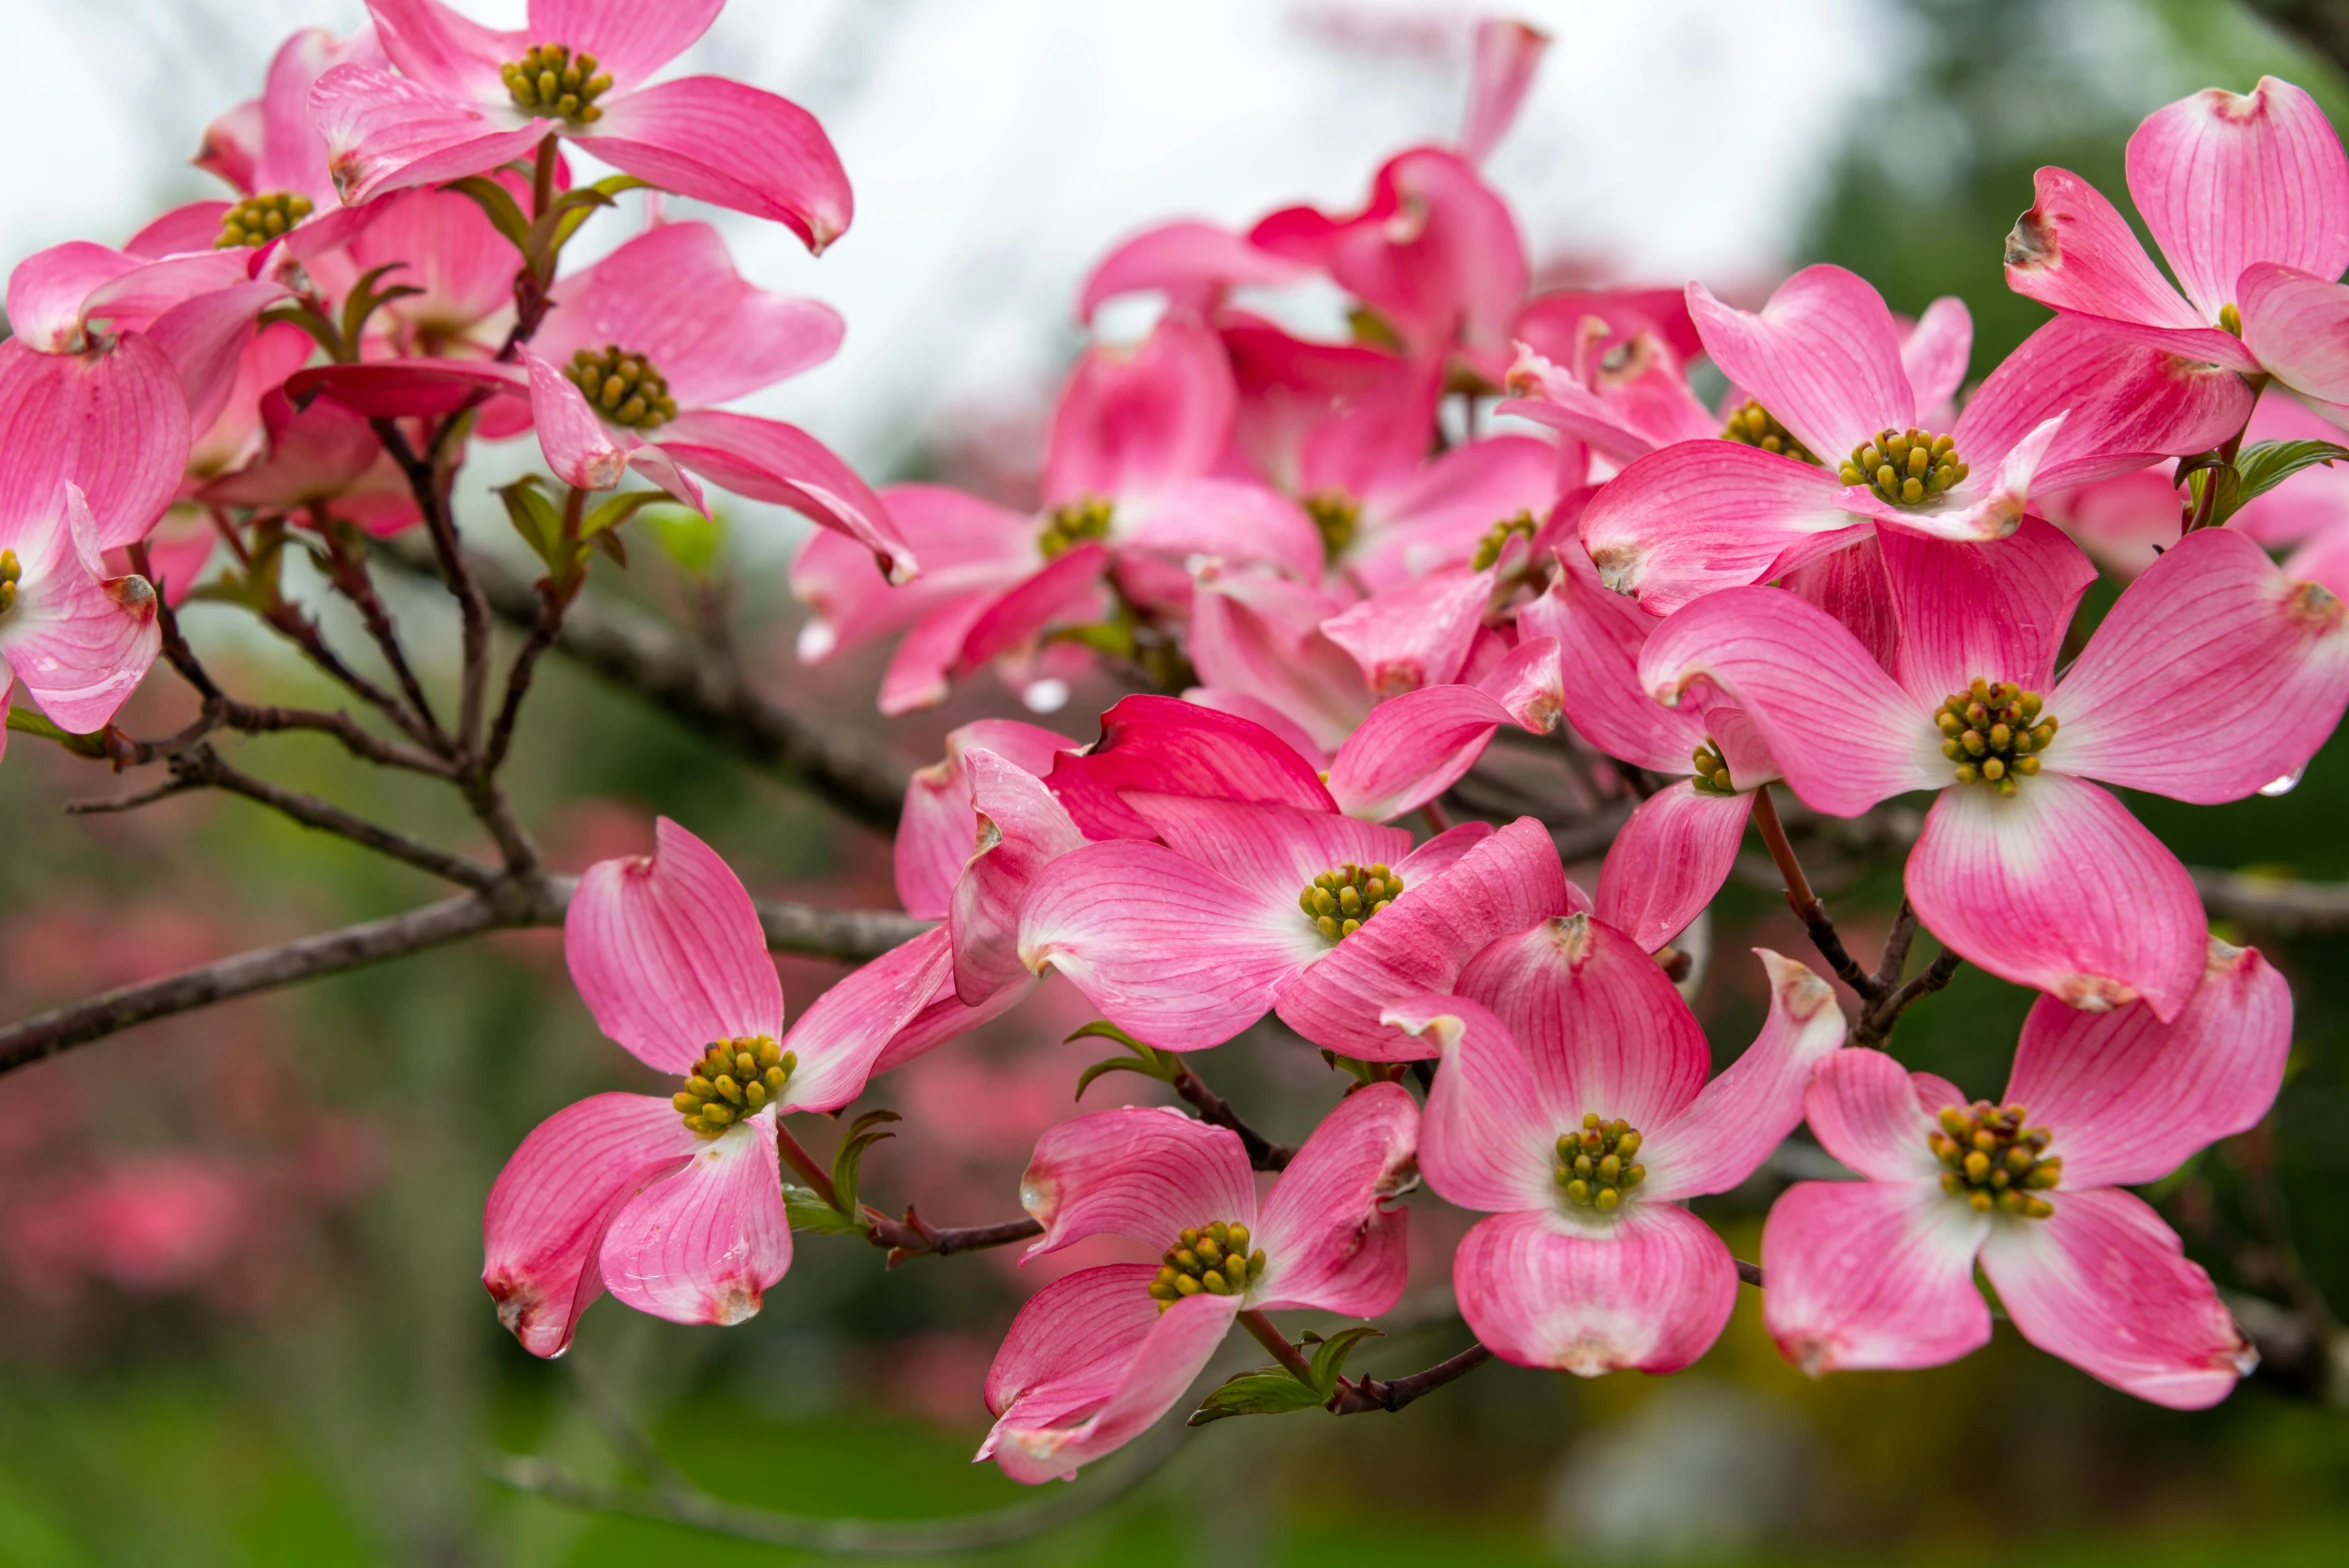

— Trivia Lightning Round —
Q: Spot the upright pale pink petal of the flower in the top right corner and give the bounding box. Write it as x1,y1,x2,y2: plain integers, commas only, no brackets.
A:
2128,75,2349,322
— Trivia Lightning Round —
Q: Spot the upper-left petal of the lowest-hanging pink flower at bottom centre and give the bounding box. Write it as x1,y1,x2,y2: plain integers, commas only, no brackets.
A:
1019,1106,1257,1261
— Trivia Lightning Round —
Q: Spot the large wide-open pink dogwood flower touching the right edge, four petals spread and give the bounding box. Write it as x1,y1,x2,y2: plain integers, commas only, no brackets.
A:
1640,519,2349,1019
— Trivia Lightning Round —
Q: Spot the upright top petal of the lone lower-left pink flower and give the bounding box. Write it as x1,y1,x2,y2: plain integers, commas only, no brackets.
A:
564,817,782,1073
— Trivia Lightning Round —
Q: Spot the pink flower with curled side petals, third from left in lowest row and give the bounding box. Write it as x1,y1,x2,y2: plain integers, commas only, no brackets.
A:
1388,915,1844,1378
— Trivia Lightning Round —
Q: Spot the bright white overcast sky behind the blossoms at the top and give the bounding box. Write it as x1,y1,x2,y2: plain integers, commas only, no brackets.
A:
0,0,1898,495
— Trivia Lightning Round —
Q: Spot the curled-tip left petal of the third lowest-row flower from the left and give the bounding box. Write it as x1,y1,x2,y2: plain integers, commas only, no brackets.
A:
1386,995,1581,1214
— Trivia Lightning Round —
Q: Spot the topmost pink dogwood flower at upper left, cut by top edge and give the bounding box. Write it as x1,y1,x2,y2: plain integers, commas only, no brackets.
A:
310,0,853,254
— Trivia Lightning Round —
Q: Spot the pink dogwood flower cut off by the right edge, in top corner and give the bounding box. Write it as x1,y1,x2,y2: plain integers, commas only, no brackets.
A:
2006,77,2349,423
